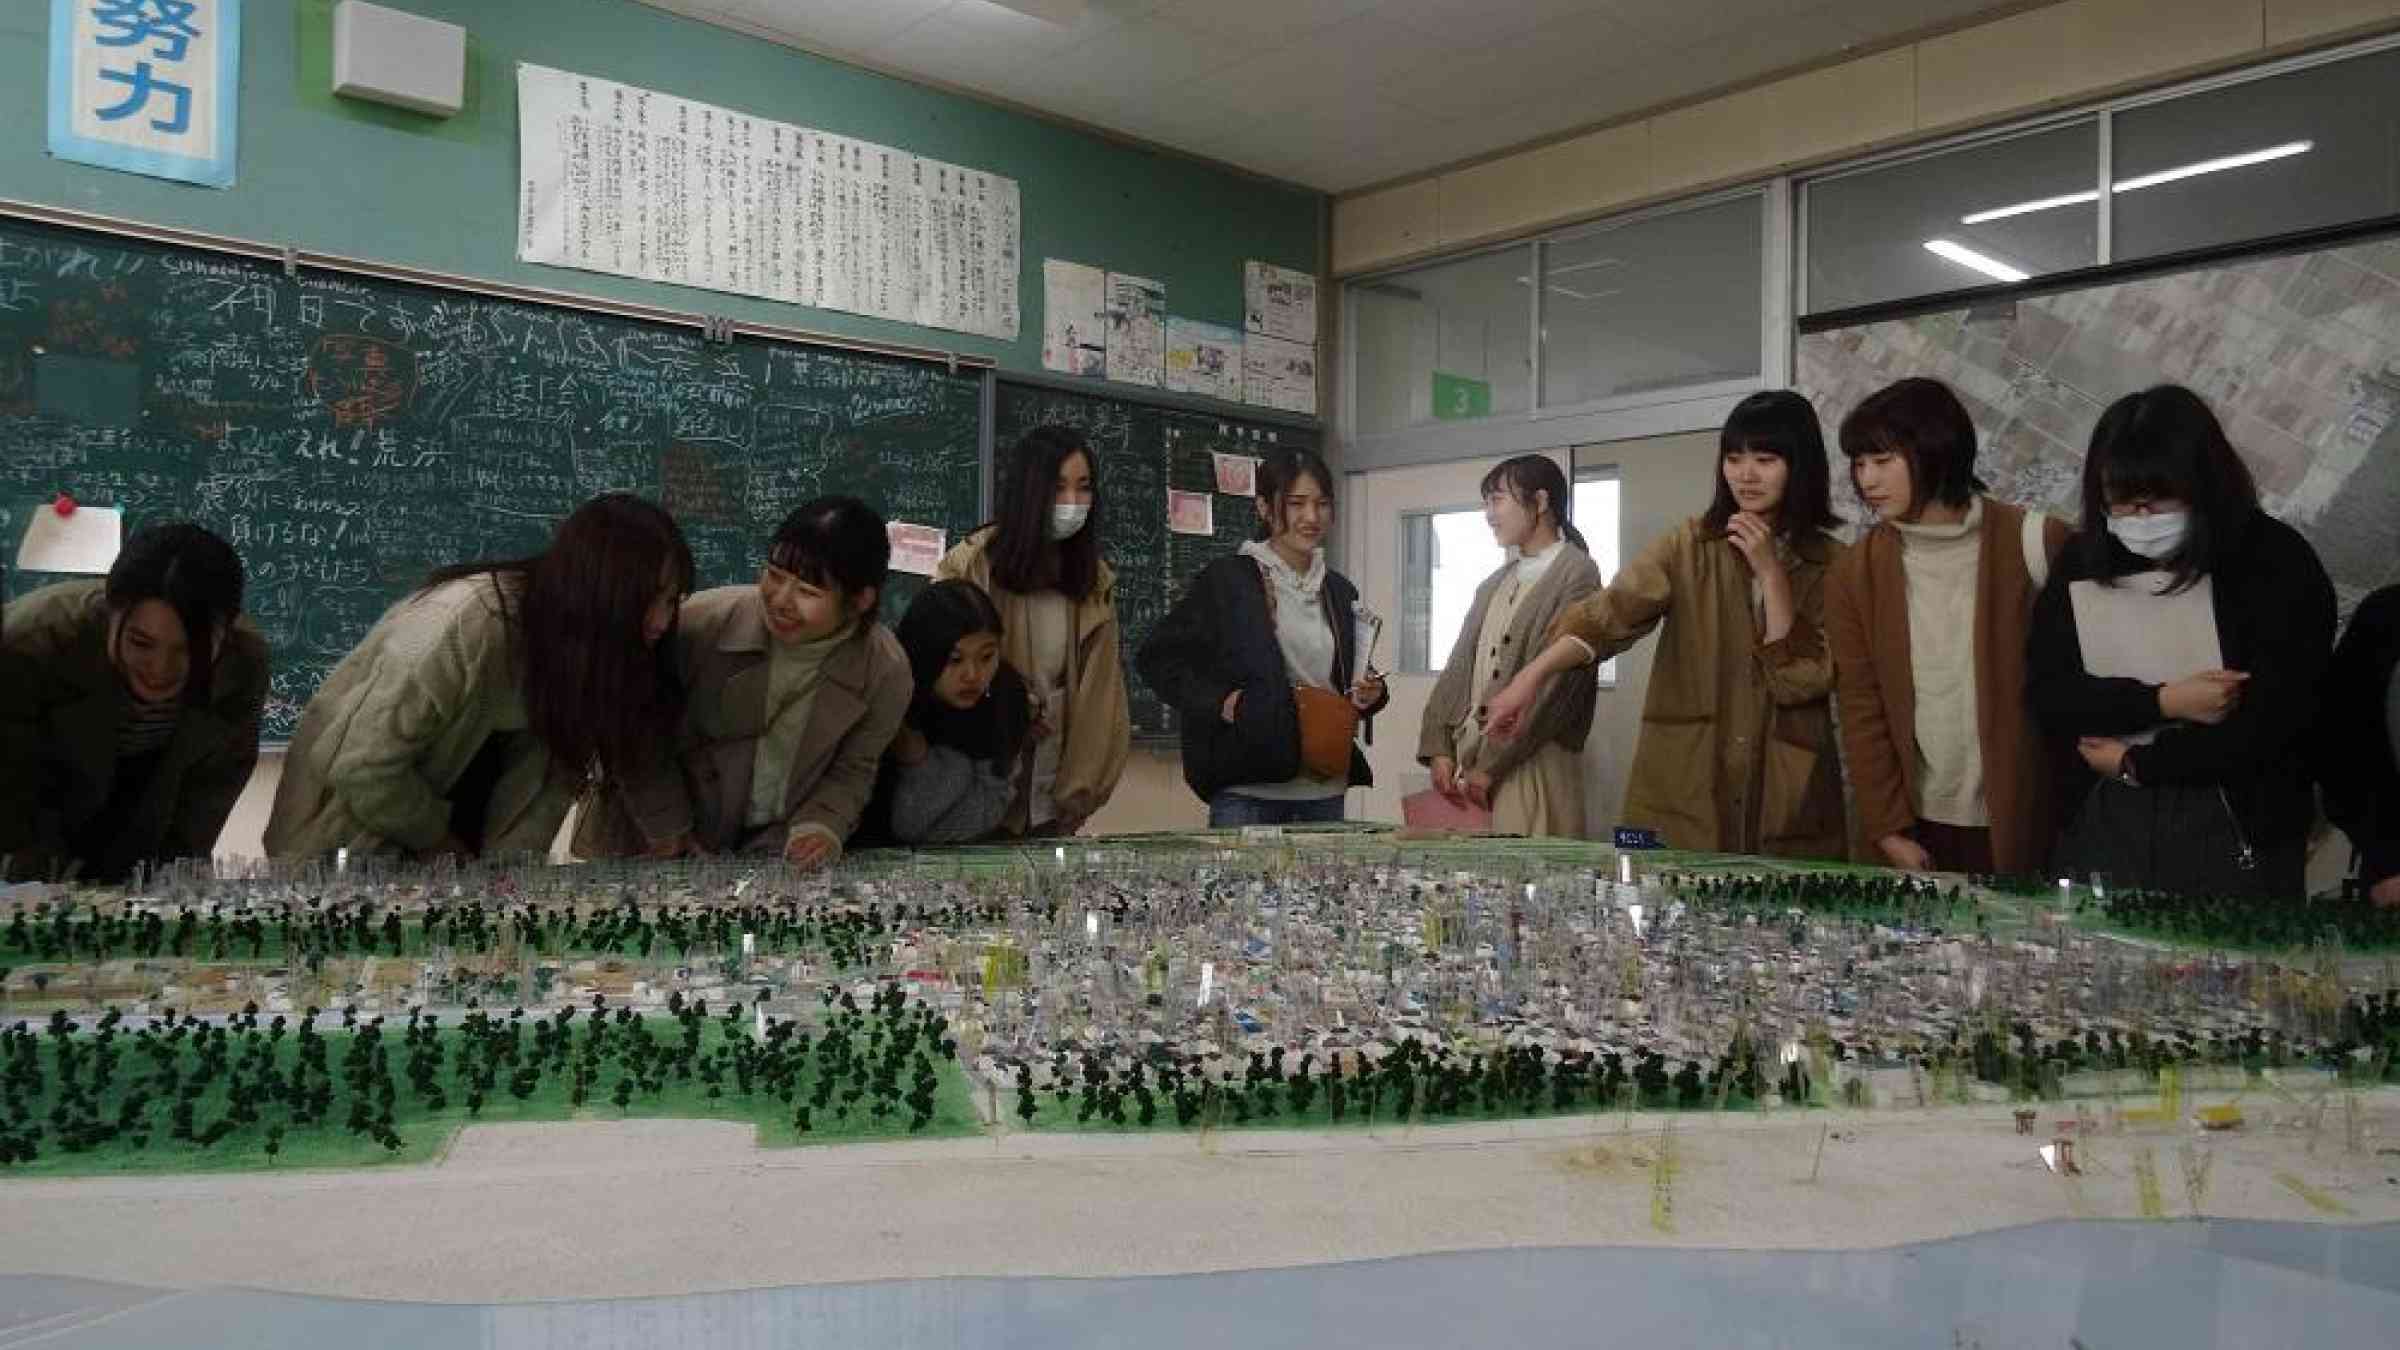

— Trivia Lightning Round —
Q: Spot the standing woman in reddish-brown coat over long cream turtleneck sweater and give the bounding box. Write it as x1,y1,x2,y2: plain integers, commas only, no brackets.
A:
1824,380,2069,874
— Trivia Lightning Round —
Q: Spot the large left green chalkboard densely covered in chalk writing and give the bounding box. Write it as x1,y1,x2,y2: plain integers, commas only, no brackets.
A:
0,221,982,740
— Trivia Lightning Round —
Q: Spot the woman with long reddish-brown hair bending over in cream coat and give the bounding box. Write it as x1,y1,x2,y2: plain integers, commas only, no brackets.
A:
266,495,691,858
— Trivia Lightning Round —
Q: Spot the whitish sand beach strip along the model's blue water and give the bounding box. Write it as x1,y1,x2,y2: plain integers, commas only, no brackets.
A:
0,1091,2400,1302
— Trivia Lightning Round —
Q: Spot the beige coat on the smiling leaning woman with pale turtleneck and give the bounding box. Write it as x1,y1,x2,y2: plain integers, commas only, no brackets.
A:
574,586,917,858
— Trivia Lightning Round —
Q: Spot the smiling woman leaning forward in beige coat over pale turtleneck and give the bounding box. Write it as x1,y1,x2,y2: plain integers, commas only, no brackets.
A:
576,497,914,867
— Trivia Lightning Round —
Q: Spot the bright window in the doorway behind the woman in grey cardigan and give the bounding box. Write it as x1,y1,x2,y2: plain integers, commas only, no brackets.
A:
1399,471,1618,682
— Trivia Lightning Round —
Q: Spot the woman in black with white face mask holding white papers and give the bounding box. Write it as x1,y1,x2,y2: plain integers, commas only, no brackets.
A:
2026,384,2335,901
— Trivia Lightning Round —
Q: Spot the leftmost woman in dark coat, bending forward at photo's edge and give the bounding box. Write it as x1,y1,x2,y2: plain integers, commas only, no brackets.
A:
0,521,266,882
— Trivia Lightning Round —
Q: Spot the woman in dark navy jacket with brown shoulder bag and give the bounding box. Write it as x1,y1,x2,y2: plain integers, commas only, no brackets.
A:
1138,447,1390,829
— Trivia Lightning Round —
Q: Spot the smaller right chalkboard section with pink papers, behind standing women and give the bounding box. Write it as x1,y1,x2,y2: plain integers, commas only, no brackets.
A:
994,380,1318,742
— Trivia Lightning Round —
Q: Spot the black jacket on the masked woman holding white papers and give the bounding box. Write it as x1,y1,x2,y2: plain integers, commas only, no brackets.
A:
2026,512,2338,848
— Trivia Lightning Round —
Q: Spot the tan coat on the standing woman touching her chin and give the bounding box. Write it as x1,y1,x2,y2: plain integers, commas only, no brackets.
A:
1550,519,1846,858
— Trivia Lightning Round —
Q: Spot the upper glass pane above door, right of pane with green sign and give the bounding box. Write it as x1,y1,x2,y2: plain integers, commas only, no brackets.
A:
1541,197,1766,408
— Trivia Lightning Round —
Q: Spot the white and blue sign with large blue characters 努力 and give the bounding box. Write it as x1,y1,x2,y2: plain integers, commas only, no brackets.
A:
50,0,242,187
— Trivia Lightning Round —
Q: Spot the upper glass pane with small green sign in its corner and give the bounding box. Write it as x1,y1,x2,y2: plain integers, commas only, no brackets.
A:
1351,247,1534,435
